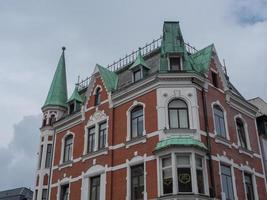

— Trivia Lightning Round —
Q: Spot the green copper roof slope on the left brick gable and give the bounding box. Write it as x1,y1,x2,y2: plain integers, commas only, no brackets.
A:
96,64,118,91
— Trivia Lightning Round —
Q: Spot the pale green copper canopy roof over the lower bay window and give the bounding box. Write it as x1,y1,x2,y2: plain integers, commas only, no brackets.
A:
155,136,207,151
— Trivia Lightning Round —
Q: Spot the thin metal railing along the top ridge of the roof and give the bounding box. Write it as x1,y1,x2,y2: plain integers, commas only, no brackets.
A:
76,36,197,90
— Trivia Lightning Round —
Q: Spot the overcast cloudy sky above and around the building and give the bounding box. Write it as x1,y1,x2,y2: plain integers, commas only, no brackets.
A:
0,0,267,190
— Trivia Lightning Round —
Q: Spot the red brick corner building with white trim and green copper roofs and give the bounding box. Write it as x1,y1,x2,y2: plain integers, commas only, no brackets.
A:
34,22,267,200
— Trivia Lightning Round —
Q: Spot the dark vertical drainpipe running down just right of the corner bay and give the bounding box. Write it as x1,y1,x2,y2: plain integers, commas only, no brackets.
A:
202,88,216,198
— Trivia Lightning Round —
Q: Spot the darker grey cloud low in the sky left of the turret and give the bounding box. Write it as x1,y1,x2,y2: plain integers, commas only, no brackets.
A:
0,116,41,190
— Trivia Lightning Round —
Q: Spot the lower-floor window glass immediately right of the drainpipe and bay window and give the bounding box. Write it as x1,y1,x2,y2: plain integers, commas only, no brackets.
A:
221,165,234,200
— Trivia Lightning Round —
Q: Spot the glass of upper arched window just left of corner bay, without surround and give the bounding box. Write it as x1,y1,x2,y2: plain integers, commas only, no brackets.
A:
131,105,144,138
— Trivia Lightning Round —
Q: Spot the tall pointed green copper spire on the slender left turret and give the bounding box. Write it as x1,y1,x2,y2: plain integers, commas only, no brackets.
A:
43,48,68,108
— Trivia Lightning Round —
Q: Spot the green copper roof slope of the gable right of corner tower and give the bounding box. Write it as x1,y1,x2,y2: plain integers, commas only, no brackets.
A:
189,44,214,73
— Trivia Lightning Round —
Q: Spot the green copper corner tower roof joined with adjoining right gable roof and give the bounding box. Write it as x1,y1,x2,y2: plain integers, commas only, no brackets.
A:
160,22,214,73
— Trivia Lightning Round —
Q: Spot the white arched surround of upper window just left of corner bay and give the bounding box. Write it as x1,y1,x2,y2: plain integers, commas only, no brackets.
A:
126,101,146,141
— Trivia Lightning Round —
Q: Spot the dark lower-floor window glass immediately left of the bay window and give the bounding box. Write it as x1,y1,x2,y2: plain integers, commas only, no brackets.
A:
131,164,144,200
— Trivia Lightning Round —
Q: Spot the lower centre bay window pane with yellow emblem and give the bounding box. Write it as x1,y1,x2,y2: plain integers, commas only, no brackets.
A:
177,168,192,192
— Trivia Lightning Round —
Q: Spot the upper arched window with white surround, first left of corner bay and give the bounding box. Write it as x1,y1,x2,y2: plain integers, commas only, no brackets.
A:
126,101,146,141
